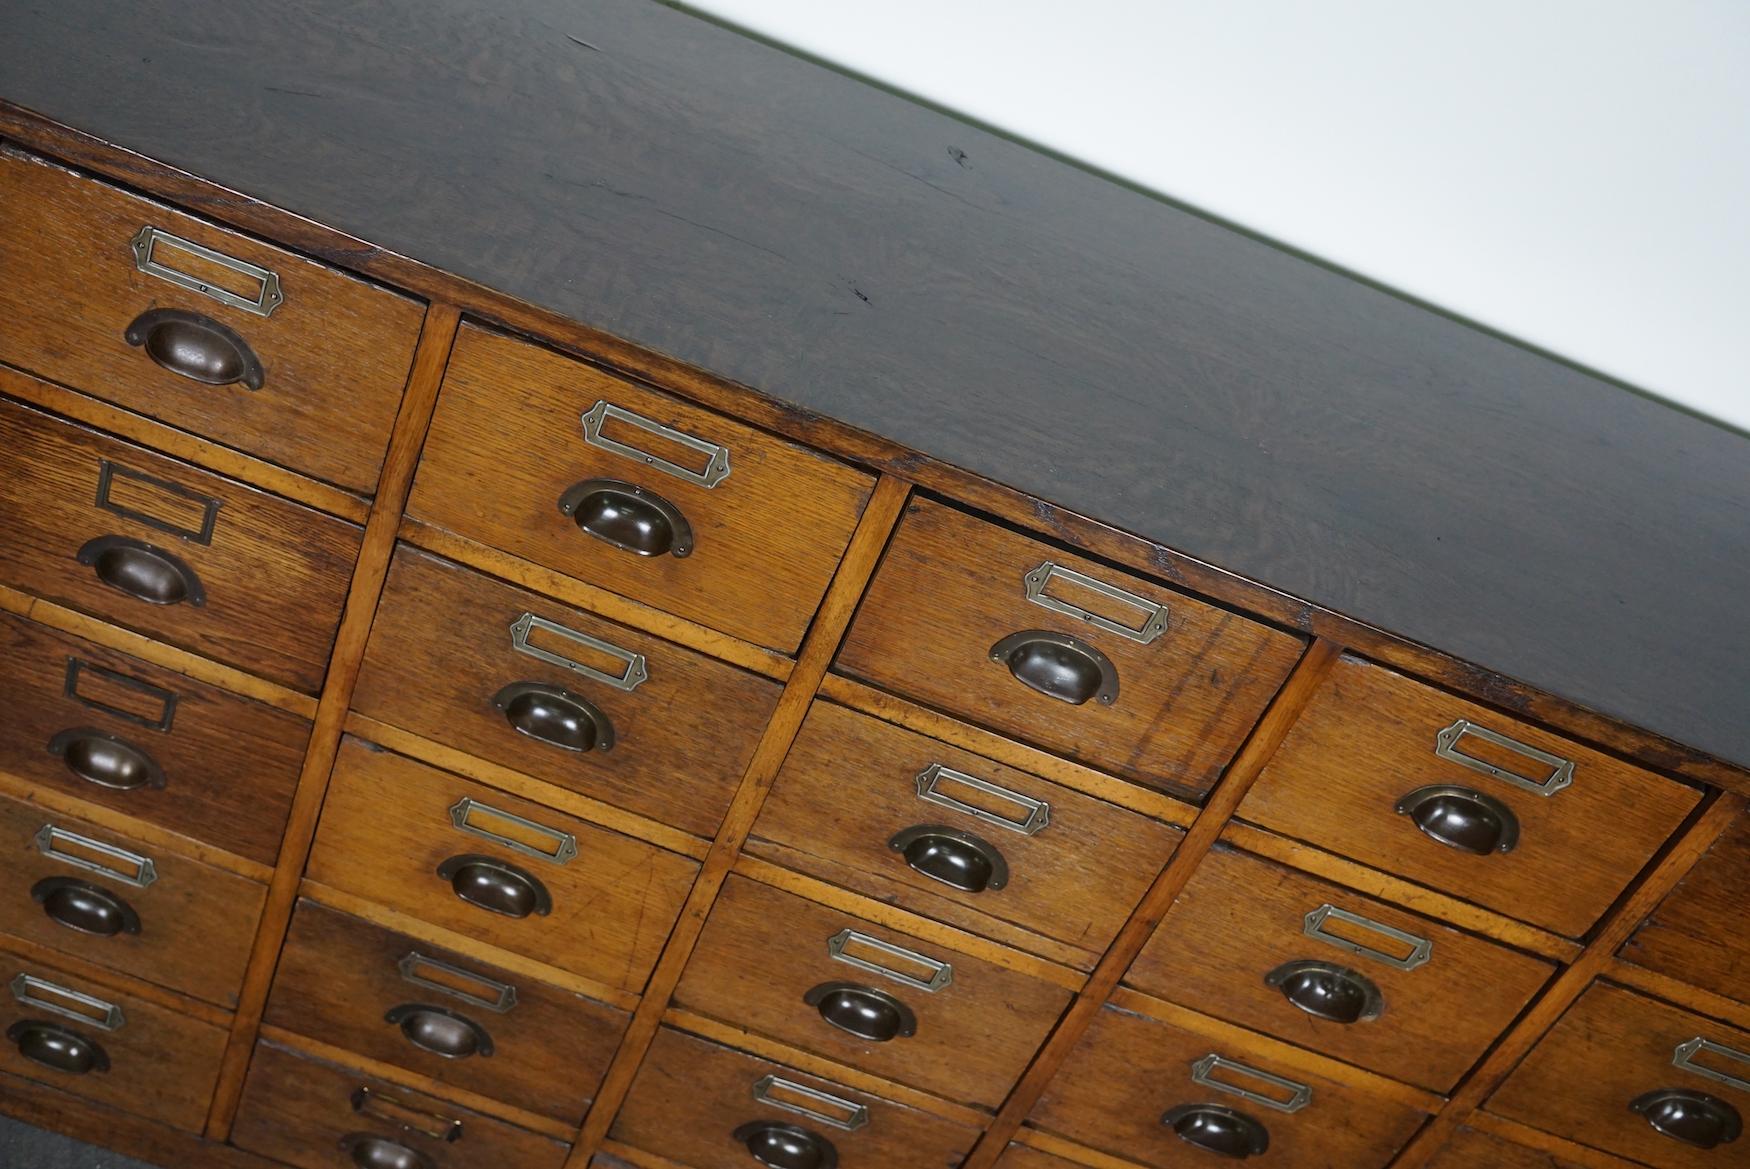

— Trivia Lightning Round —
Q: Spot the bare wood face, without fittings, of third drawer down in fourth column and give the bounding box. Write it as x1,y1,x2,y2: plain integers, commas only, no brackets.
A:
1029,1006,1423,1169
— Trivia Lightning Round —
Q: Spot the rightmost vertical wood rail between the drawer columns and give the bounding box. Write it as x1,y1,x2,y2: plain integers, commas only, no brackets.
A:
1391,793,1745,1169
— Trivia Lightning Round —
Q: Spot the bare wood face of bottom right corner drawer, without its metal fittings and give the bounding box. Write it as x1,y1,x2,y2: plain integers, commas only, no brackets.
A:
1488,982,1750,1169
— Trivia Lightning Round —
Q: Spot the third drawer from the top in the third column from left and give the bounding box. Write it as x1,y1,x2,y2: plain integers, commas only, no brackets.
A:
676,877,1069,1108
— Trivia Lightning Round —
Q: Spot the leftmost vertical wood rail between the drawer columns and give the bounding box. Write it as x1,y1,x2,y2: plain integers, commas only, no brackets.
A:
207,305,462,1141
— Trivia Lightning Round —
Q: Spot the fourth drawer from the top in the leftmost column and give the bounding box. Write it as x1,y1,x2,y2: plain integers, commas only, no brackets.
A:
0,796,266,1008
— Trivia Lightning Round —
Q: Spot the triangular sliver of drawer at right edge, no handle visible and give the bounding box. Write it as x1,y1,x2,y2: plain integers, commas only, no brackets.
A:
1621,814,1750,1003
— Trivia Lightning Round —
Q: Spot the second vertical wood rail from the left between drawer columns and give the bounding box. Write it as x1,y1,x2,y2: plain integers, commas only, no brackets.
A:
565,474,912,1169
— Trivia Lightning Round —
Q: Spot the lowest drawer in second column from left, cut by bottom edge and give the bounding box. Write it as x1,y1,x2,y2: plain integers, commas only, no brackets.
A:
231,1043,571,1169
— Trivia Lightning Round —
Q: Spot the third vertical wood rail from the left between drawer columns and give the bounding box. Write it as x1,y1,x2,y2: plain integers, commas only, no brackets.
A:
961,637,1342,1169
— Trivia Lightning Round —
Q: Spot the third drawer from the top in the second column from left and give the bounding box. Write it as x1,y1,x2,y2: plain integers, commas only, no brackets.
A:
308,739,698,991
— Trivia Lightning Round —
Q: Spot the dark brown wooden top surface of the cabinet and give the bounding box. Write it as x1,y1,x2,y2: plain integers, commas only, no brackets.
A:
0,0,1750,763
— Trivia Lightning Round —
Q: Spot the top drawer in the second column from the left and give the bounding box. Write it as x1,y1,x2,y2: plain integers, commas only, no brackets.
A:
408,326,873,653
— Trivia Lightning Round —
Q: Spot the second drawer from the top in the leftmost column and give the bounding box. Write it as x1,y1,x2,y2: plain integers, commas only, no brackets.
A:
0,399,361,693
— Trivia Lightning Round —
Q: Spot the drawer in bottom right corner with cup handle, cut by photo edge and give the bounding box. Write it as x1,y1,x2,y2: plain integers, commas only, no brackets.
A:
1488,982,1750,1169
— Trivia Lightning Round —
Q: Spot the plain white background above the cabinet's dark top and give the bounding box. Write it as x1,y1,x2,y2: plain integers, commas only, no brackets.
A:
681,0,1750,429
